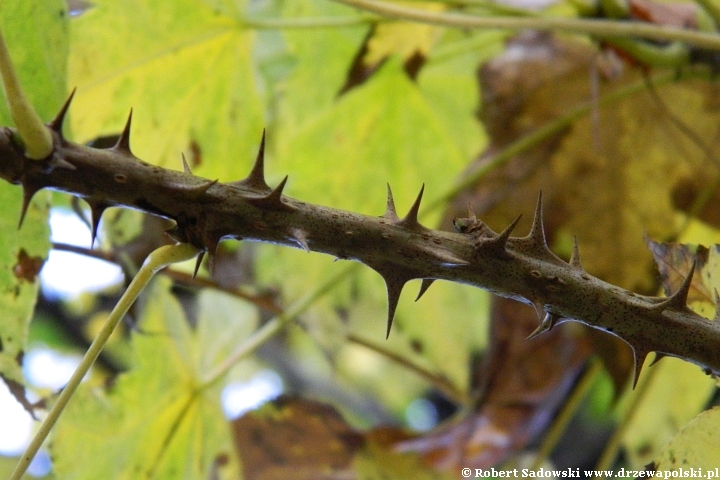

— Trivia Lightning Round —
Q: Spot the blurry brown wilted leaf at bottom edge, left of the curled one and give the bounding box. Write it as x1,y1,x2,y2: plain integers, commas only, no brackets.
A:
232,398,455,480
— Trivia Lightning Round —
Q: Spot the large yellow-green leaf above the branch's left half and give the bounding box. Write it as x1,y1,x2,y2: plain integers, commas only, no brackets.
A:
70,0,264,181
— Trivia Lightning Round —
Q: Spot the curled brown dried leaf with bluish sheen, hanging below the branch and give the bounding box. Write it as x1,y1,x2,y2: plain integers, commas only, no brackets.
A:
398,297,591,471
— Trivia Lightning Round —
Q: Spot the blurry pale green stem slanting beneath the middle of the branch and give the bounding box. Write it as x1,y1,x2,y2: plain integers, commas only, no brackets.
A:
198,263,360,390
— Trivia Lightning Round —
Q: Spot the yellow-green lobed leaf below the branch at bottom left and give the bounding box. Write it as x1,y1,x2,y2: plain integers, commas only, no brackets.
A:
52,277,257,479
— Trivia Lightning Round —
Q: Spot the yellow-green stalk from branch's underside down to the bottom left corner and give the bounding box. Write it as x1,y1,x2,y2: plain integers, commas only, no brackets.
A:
10,243,198,480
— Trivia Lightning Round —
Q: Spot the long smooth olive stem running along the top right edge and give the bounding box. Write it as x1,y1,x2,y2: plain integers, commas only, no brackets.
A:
336,0,720,50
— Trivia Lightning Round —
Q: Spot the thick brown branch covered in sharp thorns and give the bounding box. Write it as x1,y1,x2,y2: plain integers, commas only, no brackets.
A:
0,93,720,382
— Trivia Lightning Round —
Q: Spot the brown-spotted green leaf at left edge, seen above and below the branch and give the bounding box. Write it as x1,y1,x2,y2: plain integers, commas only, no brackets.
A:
0,0,68,408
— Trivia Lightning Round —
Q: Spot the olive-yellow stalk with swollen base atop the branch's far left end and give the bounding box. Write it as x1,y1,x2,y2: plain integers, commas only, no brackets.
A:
0,28,53,160
